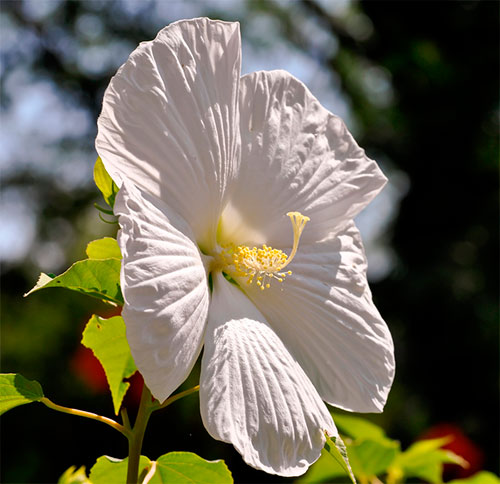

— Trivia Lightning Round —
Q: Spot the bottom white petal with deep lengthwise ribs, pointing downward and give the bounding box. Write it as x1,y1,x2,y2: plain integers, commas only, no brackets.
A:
200,273,338,476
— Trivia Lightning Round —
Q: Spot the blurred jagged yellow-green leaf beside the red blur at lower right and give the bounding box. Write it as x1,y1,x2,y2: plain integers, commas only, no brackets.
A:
389,437,468,484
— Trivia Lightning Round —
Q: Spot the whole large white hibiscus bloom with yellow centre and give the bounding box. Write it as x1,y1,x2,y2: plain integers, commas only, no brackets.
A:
96,18,394,476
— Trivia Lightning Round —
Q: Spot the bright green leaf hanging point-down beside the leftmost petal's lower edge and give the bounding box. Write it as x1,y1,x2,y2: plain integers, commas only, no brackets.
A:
82,315,137,415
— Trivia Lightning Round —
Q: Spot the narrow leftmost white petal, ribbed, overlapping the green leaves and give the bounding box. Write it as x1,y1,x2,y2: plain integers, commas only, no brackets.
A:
115,182,209,401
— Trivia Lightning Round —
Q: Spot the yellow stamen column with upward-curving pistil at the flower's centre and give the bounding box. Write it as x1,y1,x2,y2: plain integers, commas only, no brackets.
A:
220,212,309,291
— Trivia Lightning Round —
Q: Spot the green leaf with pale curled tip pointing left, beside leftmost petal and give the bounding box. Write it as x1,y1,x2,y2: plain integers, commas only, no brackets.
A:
24,259,123,305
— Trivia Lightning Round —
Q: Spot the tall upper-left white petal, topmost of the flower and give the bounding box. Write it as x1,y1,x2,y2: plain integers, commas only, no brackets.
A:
96,18,241,250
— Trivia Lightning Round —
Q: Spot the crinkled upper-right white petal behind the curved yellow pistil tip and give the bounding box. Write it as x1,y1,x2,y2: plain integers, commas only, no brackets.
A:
219,71,386,248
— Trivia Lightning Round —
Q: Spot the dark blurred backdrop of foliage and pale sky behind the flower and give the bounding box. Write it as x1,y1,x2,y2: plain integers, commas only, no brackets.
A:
0,0,500,483
